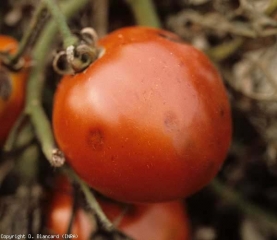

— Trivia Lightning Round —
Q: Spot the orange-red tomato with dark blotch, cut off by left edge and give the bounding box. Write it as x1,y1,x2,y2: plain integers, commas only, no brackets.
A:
0,35,28,146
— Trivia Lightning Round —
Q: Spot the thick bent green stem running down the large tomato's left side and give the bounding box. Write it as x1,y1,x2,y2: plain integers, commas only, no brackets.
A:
25,0,89,160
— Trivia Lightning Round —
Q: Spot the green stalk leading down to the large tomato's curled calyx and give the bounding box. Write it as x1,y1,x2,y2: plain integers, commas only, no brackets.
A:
44,0,77,48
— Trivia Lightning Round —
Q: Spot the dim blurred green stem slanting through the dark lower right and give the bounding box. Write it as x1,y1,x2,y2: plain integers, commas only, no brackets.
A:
211,179,277,232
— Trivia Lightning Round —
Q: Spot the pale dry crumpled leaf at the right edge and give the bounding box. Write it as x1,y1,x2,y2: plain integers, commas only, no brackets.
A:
231,46,277,164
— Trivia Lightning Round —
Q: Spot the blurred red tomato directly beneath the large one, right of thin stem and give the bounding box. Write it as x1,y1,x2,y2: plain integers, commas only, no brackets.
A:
100,201,190,240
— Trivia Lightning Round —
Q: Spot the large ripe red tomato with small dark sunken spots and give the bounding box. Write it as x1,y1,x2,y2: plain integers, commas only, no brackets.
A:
53,27,231,203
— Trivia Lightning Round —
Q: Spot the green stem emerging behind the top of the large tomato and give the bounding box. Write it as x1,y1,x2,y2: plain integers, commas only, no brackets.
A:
126,0,161,28
